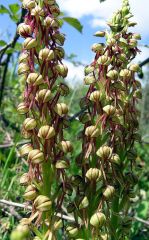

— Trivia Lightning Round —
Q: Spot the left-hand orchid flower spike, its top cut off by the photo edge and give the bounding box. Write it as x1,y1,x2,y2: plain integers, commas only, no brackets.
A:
11,0,72,240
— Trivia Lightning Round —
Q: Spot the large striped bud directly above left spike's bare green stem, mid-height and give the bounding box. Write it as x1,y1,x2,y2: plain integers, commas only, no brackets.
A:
38,125,55,140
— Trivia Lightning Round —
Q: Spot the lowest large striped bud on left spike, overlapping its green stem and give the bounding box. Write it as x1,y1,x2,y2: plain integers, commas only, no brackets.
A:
34,195,52,212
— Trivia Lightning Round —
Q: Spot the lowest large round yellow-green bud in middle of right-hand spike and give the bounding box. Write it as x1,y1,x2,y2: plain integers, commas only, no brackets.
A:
90,212,106,228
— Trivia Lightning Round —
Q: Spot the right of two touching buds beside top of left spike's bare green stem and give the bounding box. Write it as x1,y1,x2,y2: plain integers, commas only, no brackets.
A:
28,149,44,164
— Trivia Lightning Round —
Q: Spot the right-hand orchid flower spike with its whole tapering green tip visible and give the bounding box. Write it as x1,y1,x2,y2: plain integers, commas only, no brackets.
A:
67,0,141,240
